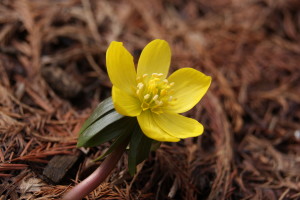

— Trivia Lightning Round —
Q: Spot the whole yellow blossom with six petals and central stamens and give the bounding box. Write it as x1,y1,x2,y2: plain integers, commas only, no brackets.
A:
106,39,211,142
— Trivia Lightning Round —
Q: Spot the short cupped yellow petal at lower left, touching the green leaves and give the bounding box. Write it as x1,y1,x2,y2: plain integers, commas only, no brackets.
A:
112,86,142,117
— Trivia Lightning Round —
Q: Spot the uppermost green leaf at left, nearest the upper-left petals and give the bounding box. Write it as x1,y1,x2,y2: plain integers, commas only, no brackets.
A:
79,97,114,134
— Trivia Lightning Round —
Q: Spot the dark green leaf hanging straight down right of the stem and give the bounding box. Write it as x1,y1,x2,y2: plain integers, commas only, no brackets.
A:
128,124,153,176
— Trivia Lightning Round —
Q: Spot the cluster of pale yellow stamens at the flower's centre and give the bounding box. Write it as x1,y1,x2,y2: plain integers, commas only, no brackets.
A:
136,73,176,114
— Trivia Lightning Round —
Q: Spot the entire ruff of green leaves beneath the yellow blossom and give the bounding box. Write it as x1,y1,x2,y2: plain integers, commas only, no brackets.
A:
77,98,157,175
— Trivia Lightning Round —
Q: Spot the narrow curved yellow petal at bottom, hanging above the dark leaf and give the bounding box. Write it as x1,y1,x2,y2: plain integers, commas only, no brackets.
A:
137,111,180,142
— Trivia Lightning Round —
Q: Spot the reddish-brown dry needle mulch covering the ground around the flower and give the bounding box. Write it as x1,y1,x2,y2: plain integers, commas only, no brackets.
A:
0,0,300,200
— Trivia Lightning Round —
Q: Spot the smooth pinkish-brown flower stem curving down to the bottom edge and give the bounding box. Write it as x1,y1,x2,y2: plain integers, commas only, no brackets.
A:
63,142,128,200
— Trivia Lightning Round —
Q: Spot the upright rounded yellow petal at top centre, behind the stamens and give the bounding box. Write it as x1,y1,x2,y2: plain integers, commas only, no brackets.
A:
137,39,171,78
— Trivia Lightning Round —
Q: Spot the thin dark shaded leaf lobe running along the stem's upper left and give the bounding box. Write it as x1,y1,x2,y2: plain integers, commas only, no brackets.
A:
94,117,138,161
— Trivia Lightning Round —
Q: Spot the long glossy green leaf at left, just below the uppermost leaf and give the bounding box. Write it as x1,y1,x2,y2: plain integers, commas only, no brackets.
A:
77,111,124,147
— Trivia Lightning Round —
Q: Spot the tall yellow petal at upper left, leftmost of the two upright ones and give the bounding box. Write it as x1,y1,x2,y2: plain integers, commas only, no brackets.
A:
106,41,136,94
